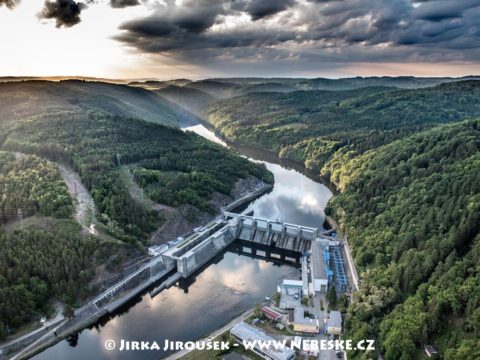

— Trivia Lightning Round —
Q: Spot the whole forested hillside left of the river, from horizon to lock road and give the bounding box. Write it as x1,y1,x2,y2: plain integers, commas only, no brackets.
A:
0,81,273,339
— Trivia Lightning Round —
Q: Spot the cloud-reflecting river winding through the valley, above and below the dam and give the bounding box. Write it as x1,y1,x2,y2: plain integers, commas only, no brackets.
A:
35,125,332,360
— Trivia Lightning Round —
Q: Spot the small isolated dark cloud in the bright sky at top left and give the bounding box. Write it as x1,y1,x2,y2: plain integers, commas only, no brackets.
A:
39,0,87,28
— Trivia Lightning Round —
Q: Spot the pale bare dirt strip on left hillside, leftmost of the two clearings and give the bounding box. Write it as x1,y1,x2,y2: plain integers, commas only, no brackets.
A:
57,164,97,235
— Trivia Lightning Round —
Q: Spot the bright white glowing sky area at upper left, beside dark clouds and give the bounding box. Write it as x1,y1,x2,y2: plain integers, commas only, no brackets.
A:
0,0,145,77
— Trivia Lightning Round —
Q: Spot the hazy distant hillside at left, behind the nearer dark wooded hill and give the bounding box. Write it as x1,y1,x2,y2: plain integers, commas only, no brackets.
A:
0,80,181,126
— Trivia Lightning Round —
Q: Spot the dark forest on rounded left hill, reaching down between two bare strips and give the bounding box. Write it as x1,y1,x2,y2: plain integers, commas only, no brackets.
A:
2,112,273,243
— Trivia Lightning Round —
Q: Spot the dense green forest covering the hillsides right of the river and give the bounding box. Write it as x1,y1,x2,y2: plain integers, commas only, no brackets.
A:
204,81,480,360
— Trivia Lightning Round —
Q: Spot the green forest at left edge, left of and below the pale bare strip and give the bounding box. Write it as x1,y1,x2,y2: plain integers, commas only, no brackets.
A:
0,155,110,339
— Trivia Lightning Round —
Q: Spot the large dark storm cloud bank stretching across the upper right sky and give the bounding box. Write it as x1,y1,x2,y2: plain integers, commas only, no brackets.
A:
116,0,480,61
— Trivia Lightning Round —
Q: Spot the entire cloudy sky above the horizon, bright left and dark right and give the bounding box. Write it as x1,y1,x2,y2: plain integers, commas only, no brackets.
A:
0,0,480,79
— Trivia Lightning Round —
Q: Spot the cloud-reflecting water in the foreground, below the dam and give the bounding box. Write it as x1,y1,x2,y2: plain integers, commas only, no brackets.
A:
35,252,298,360
